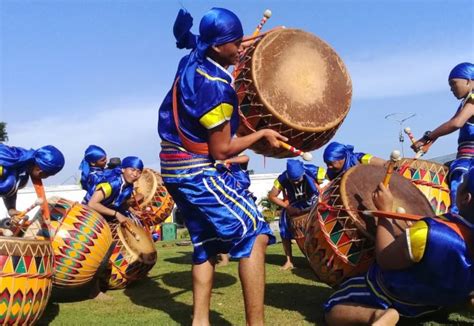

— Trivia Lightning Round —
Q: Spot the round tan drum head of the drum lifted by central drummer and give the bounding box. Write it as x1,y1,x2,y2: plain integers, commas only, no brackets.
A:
252,29,352,132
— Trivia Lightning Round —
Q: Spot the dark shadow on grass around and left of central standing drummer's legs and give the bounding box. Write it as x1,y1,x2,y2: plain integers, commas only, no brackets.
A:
124,272,237,325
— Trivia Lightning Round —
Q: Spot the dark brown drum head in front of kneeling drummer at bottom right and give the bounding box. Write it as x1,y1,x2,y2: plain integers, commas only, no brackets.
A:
340,165,435,236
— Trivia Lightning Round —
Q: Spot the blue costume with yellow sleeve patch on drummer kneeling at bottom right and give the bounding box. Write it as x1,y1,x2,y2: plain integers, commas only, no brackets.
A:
325,213,474,317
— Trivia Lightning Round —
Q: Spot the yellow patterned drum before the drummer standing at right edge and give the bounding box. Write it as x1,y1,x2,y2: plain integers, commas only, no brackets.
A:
396,158,451,215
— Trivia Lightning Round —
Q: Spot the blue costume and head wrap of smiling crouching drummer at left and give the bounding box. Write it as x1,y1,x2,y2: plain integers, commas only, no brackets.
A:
83,156,143,222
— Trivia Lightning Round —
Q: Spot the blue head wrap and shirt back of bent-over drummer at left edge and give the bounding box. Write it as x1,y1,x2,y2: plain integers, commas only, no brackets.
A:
0,144,64,175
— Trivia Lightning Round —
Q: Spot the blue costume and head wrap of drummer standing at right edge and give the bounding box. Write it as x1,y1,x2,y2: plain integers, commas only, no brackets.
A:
448,62,474,213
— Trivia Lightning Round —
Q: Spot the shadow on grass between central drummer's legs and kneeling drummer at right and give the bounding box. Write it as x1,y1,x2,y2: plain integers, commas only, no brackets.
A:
265,283,333,325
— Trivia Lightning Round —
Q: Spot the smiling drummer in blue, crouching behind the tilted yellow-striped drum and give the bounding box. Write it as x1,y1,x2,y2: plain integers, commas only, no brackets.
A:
83,156,143,223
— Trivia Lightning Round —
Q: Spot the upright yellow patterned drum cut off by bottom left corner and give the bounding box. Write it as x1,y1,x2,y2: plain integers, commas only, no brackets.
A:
0,236,54,325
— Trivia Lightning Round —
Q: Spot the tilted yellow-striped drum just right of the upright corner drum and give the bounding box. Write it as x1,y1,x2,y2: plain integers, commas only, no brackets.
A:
38,197,112,287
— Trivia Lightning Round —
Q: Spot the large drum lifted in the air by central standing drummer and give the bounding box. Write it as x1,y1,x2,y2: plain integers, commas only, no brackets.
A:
235,29,352,157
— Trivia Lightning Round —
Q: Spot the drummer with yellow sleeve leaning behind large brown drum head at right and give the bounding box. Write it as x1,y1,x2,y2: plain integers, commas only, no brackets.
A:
324,142,386,180
